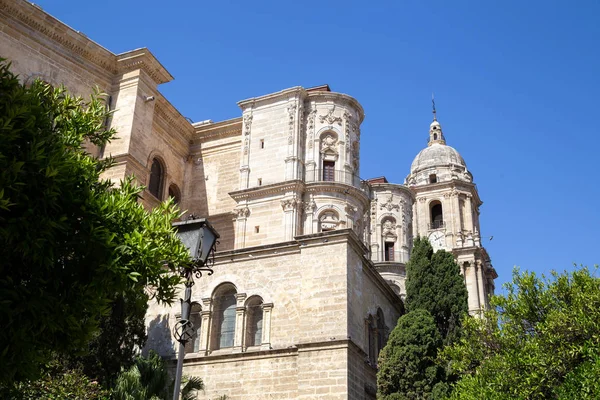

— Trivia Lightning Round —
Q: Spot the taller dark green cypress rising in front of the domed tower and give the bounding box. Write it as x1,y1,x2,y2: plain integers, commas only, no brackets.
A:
406,238,468,343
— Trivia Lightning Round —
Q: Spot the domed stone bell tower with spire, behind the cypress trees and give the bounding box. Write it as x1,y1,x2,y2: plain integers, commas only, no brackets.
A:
406,103,497,314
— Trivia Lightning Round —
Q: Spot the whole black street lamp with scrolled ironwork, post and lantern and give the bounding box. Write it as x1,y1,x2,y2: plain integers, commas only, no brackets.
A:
173,217,219,400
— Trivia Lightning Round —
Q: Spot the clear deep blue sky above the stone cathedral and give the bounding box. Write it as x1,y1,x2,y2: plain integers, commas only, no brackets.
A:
36,0,600,287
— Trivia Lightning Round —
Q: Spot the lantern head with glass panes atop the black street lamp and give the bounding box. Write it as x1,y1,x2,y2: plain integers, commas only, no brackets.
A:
173,218,219,263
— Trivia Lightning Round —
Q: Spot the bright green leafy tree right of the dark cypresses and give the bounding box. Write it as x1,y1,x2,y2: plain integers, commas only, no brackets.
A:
441,268,600,399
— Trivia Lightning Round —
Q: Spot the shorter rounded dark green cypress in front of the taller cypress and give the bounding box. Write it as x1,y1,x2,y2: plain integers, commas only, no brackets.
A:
377,309,443,400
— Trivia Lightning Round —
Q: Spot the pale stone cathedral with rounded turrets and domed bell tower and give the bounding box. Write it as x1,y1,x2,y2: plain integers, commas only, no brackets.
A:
0,0,497,400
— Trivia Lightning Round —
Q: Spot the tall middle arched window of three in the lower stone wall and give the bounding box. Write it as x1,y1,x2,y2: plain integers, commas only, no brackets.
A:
211,284,236,350
